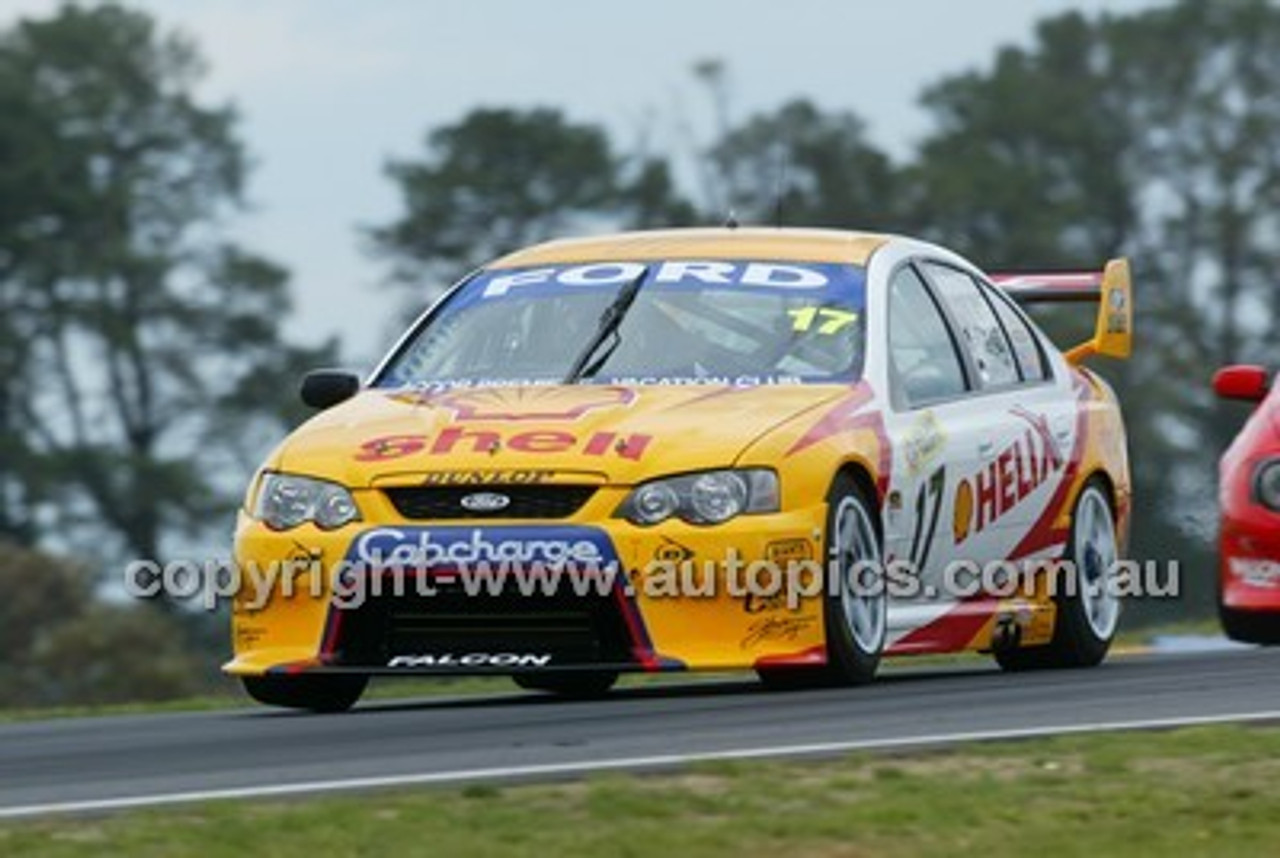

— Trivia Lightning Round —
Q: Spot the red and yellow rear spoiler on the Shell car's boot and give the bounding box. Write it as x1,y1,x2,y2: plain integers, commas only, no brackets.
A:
991,259,1133,364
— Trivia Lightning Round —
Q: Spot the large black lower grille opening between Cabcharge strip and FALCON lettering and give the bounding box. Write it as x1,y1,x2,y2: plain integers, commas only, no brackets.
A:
334,587,632,668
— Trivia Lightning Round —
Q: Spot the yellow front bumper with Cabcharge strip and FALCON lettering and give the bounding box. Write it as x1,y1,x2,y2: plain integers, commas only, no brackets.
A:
224,501,827,675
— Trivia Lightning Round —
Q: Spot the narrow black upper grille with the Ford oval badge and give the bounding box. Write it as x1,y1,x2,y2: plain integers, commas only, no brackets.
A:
385,485,595,521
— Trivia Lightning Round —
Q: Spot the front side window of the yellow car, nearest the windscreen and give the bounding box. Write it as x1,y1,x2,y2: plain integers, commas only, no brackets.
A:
888,268,969,407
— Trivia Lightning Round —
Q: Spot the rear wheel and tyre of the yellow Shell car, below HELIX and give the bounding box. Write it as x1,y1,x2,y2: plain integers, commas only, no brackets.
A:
995,479,1120,671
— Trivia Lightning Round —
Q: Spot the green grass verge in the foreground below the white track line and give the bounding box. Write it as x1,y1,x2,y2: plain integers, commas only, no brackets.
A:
0,727,1280,858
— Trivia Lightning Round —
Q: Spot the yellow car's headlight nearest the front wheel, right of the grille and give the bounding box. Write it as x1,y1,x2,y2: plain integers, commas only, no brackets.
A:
614,467,780,525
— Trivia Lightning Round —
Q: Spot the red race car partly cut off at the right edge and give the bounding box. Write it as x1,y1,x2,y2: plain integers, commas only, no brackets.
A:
1213,366,1280,644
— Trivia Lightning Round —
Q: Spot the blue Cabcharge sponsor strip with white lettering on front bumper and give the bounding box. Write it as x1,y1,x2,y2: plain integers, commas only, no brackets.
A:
348,528,614,571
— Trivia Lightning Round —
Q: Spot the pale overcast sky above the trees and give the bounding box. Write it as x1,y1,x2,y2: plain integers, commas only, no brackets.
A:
0,0,1156,364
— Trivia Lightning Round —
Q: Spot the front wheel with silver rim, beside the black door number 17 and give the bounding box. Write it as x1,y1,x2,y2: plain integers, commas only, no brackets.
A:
756,474,888,689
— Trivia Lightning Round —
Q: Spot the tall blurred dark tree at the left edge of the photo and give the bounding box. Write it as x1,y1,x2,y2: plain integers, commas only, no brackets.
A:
0,4,332,568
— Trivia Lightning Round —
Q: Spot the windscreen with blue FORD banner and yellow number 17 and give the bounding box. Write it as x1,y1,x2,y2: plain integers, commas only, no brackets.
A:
375,260,865,387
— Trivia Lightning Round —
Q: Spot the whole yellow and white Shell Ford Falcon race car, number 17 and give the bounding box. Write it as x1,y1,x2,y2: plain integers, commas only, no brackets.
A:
225,228,1133,711
